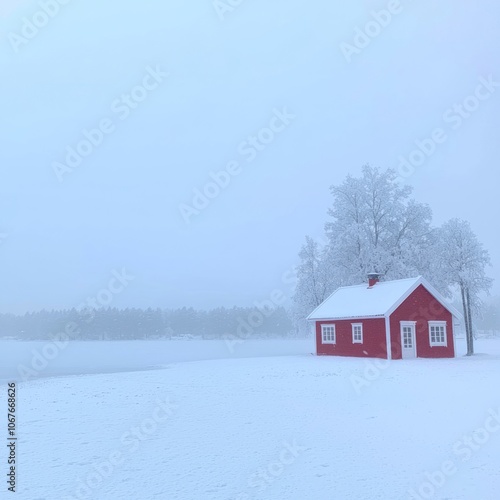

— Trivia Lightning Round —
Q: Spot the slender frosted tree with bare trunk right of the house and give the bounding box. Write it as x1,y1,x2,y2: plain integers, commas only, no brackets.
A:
438,219,492,356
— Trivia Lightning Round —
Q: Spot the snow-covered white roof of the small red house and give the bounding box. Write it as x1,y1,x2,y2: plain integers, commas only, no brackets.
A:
307,276,460,320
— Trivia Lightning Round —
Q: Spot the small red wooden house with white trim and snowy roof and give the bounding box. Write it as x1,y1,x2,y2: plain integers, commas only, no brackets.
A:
307,273,461,359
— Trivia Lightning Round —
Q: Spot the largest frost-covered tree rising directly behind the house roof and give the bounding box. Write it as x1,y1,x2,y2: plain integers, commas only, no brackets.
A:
326,165,433,285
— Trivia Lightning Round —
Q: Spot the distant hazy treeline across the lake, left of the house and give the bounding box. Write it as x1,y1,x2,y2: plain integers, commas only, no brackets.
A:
0,307,294,340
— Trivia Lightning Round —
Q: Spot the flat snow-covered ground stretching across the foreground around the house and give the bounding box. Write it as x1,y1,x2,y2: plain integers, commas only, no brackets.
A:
0,339,500,500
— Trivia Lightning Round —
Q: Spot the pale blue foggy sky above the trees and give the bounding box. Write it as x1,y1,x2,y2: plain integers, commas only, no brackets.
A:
0,0,500,312
